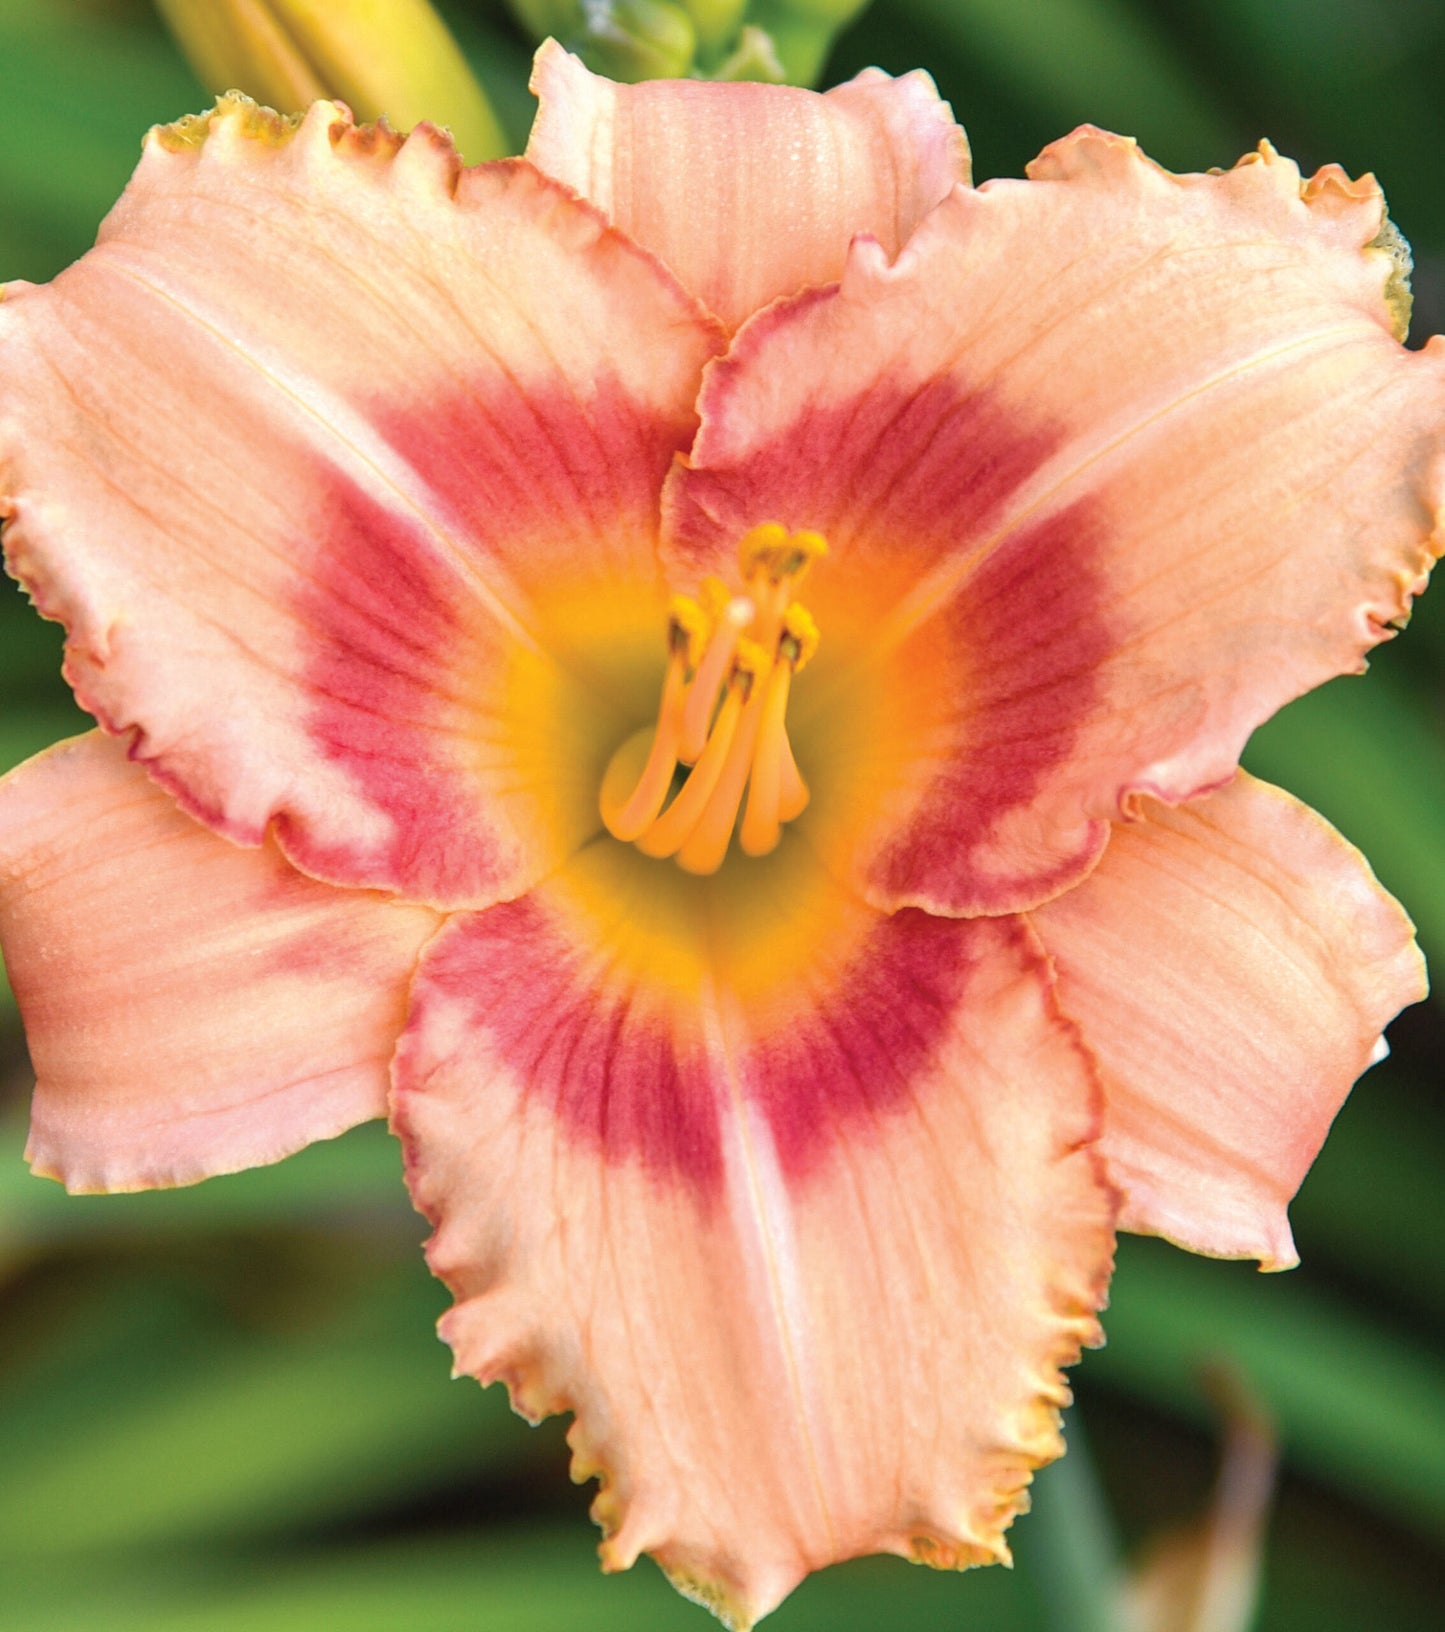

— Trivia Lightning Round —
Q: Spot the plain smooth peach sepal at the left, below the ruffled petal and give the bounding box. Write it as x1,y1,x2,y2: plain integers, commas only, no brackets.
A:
0,733,438,1191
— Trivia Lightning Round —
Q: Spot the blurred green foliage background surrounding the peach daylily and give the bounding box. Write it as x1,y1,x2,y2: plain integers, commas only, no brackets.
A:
0,0,1445,1632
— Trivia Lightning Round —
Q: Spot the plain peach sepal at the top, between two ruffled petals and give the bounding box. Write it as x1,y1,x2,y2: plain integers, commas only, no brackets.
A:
527,41,968,328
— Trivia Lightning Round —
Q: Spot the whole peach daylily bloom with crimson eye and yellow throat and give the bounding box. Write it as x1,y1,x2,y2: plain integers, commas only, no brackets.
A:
0,49,1445,1625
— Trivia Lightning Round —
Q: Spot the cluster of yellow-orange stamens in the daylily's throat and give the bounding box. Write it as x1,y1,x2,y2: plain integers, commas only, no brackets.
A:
598,522,828,873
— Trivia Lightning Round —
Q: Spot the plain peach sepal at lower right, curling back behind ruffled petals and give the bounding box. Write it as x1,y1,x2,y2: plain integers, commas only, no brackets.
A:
1034,772,1425,1268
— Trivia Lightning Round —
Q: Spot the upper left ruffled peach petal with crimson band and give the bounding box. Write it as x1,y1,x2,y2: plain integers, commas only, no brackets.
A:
0,100,720,902
